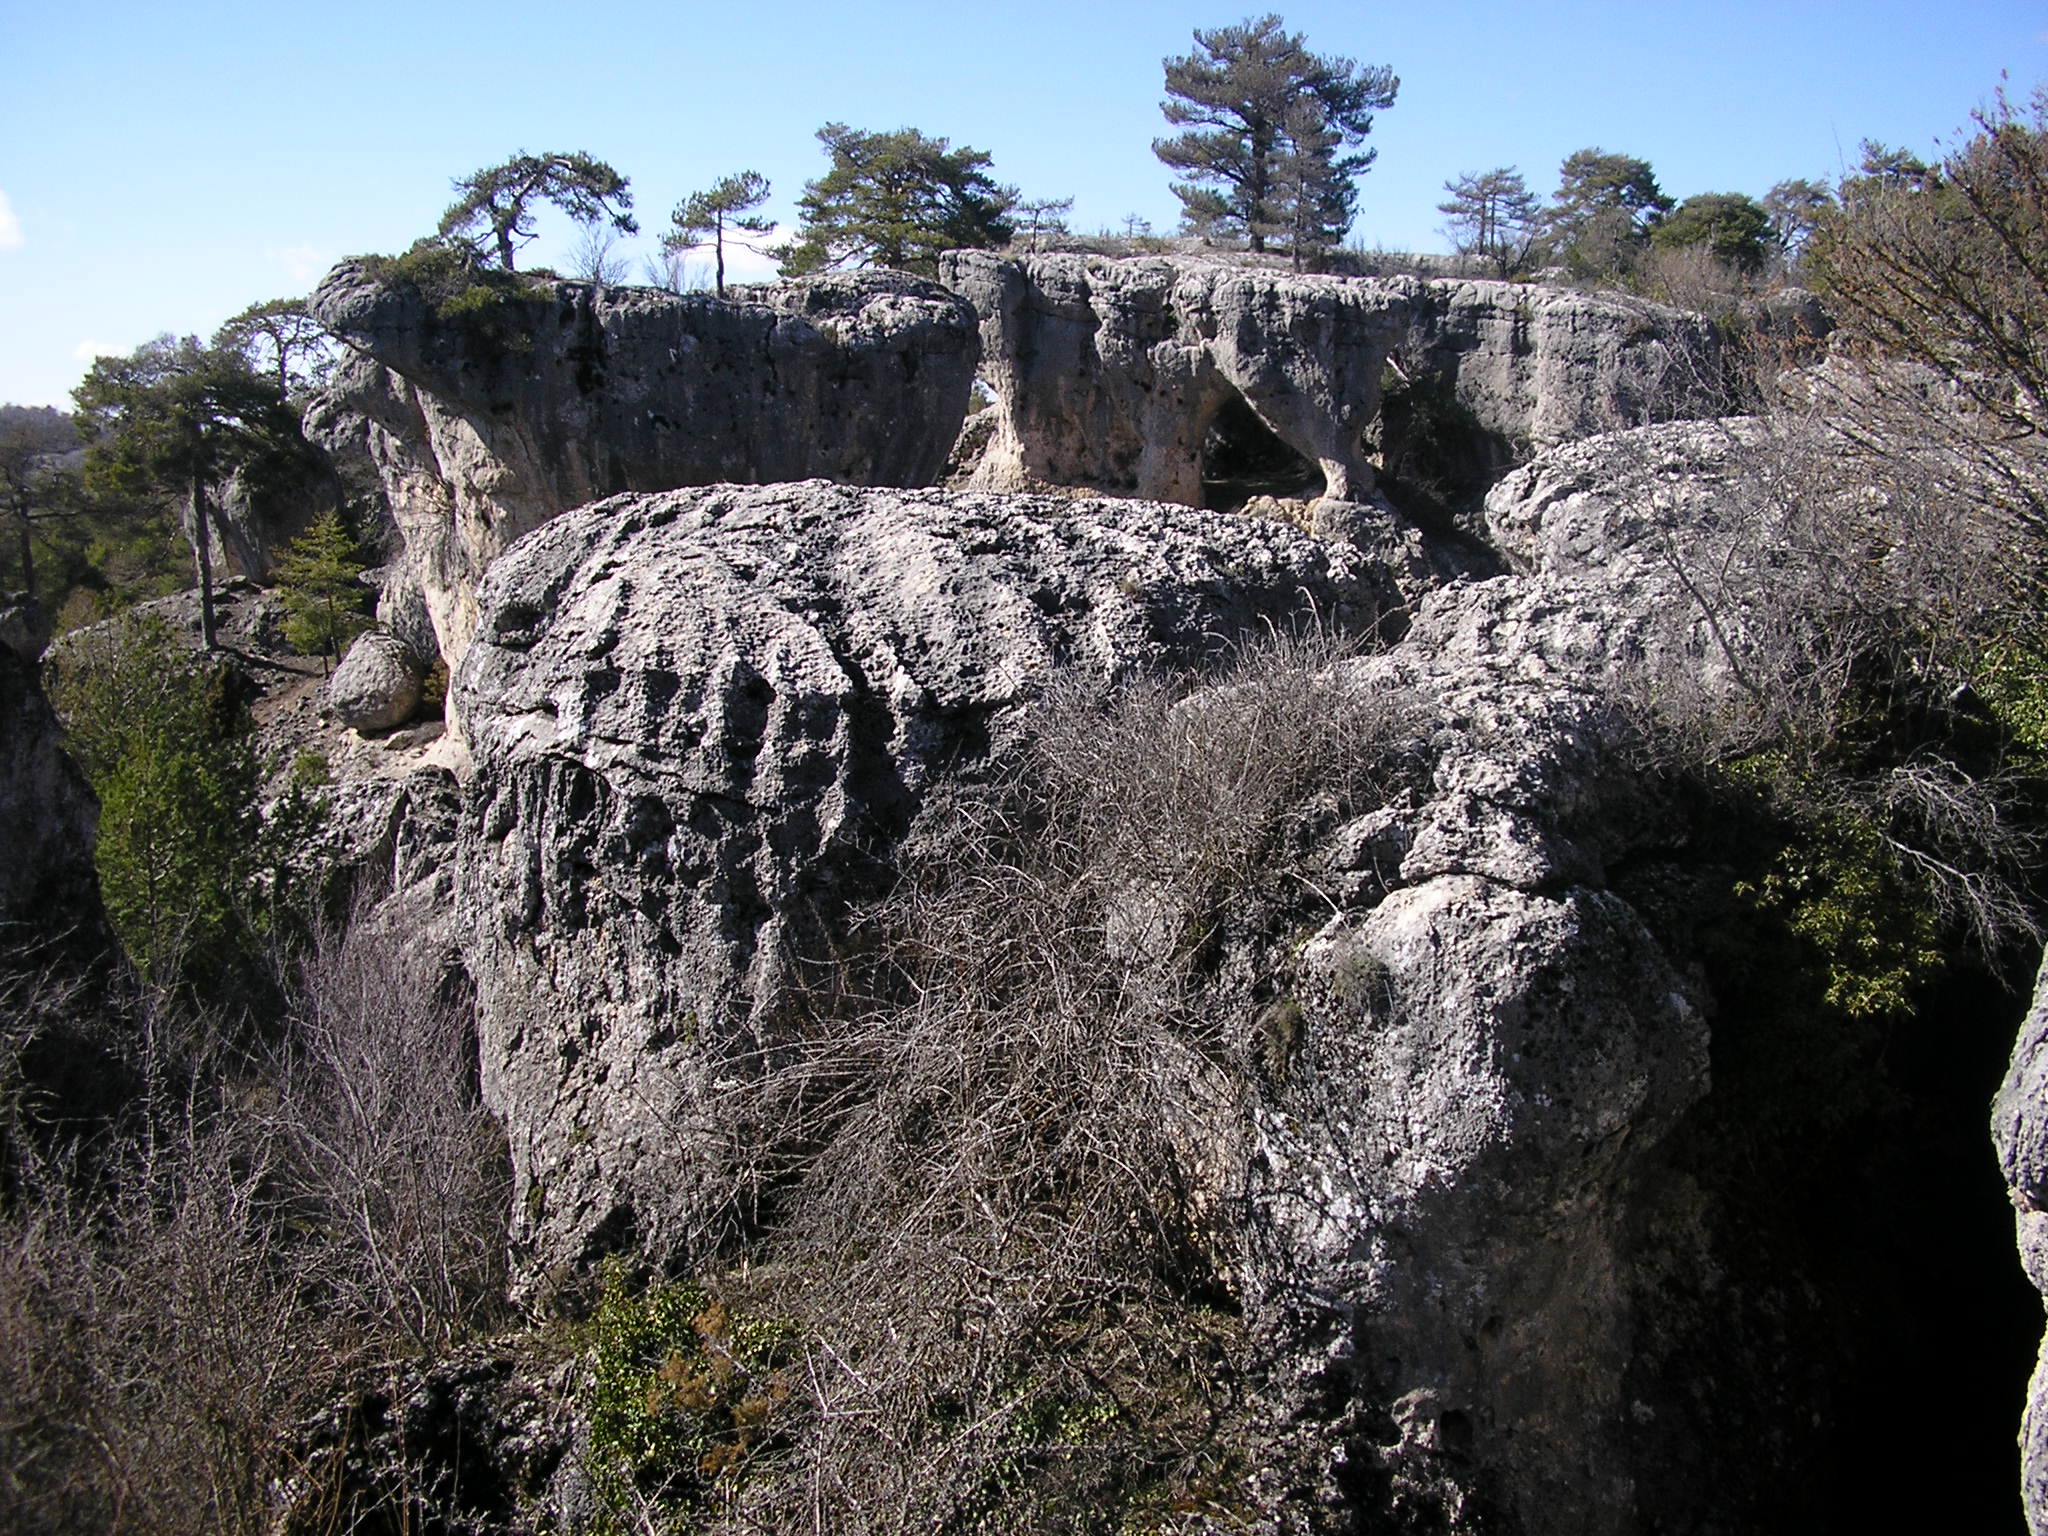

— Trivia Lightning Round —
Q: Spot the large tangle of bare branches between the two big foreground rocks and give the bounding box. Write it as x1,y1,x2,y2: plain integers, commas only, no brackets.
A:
696,643,1407,1530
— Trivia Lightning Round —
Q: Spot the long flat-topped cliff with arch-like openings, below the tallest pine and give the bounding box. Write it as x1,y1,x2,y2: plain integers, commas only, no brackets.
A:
944,252,1722,518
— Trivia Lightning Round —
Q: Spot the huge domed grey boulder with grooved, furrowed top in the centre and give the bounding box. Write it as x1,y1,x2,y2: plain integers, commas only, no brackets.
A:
455,481,1395,1276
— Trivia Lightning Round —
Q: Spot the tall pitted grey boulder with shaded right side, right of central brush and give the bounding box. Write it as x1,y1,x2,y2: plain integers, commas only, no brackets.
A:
1243,578,1708,1536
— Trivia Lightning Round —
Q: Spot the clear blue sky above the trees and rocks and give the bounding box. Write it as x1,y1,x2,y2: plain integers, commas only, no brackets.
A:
0,0,2048,403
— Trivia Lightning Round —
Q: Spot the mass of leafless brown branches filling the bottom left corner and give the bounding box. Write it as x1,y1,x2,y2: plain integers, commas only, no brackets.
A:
0,909,504,1532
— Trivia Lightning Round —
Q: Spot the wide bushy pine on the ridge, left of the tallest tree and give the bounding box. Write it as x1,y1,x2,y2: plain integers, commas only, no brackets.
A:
776,123,1018,276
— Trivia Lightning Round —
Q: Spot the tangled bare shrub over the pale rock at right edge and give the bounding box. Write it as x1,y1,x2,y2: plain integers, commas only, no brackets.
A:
1622,403,2042,954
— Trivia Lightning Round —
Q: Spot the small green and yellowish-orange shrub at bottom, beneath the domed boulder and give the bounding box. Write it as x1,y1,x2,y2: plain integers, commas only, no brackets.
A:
590,1262,797,1516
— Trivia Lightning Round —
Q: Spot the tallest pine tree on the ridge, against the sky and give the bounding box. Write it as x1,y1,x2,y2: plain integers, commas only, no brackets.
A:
1153,14,1401,268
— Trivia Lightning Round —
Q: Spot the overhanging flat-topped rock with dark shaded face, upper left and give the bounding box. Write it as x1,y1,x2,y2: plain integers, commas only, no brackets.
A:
307,262,977,666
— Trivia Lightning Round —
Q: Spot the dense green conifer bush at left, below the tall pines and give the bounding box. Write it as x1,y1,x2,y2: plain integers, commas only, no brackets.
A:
51,618,266,987
